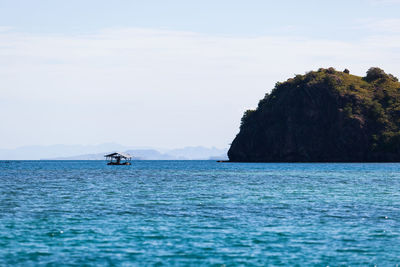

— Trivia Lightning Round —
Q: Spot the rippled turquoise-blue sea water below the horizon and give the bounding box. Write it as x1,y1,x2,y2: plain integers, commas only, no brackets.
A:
0,161,400,266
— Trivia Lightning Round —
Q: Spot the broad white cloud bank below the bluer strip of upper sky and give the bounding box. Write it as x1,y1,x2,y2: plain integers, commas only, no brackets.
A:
0,28,400,150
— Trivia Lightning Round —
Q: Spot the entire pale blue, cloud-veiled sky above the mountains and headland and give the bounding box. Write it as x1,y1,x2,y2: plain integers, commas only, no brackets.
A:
0,0,400,148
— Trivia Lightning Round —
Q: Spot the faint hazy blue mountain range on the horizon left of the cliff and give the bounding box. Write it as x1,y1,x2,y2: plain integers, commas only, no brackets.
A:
0,143,227,160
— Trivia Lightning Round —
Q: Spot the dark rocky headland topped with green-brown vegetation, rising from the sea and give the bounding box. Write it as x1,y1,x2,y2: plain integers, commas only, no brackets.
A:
228,68,400,162
